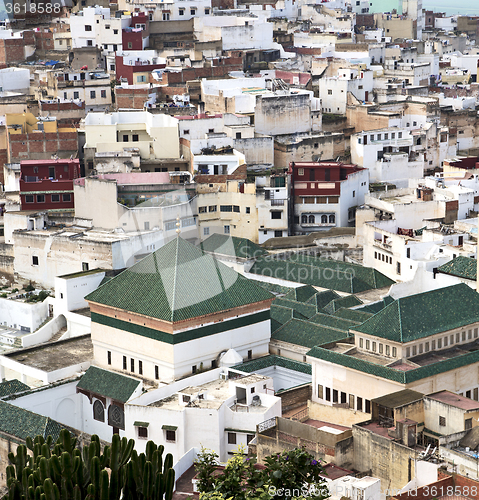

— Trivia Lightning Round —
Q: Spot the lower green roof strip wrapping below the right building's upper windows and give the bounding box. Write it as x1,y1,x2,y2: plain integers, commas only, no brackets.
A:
307,346,479,384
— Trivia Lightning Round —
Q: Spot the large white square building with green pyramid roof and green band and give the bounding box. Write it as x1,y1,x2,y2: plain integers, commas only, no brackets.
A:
86,237,273,382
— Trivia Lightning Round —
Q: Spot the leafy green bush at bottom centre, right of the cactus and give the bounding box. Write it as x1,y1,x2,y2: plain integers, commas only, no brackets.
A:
195,448,330,500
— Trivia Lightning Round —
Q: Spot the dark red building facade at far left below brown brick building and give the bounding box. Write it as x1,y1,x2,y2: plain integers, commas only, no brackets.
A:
20,159,80,210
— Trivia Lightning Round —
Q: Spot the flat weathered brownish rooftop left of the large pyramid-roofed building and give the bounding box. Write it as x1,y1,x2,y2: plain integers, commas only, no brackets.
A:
5,335,93,372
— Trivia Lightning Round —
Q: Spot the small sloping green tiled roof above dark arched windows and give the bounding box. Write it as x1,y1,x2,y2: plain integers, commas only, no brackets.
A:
77,366,140,403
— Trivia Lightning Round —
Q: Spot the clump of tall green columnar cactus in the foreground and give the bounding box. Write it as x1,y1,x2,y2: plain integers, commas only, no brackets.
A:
3,429,175,500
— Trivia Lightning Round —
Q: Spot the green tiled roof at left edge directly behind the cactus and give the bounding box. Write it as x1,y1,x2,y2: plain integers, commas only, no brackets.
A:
0,401,64,441
